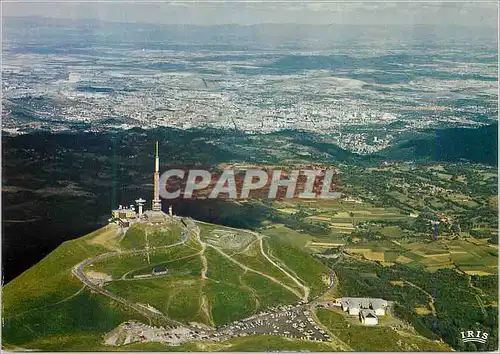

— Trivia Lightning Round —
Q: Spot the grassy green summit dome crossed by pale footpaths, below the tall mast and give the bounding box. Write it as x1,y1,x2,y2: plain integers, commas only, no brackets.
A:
2,219,331,350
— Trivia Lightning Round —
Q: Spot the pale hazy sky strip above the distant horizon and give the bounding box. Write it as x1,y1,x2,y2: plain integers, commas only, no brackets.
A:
2,0,498,28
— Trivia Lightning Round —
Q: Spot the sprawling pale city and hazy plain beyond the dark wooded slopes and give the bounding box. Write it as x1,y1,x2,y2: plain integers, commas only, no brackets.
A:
2,18,497,154
